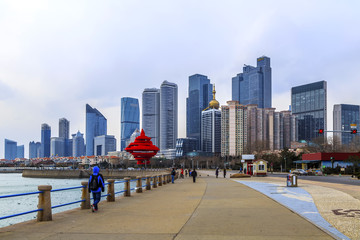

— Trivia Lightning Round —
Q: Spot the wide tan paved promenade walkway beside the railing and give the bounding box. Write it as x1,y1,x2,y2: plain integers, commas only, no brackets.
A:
0,176,333,240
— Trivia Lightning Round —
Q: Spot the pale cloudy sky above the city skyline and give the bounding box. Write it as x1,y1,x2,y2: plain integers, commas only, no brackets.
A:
0,0,360,158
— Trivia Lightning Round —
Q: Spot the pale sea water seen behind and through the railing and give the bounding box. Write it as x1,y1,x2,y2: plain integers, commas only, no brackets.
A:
0,173,129,227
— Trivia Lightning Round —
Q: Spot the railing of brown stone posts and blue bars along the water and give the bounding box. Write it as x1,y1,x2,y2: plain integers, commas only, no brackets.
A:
0,174,170,224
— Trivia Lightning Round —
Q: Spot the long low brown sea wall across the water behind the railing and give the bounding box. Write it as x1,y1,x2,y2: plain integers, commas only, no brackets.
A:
22,169,170,179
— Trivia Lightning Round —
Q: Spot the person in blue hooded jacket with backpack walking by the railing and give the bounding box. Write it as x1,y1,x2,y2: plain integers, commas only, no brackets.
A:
88,166,105,212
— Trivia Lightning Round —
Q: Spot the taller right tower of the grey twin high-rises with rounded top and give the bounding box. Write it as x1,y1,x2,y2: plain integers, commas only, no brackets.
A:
160,81,178,150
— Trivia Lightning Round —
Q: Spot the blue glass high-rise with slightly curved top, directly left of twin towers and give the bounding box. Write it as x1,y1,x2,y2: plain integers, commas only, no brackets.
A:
121,97,140,151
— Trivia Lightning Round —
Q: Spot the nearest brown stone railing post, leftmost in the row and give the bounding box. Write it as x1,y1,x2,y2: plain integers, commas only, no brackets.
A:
37,185,52,222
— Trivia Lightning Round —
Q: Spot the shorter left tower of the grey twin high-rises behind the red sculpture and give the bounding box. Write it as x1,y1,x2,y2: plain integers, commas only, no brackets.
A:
141,88,160,147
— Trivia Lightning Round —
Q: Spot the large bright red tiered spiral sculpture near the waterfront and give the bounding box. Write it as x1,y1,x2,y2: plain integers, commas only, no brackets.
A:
125,129,159,165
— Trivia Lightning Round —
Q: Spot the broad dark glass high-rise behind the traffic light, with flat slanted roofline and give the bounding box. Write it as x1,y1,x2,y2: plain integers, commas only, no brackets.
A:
291,81,327,141
